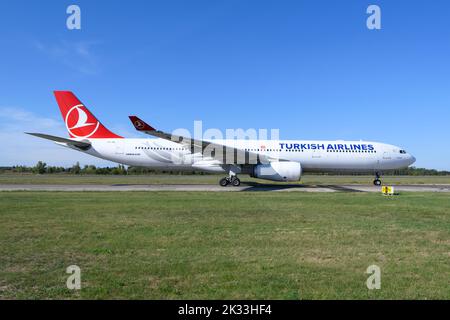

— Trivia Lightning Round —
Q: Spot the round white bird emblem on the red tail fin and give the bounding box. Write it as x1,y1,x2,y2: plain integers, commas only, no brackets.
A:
66,104,100,138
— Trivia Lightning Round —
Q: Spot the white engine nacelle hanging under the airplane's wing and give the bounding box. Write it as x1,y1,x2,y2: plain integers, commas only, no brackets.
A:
252,161,302,181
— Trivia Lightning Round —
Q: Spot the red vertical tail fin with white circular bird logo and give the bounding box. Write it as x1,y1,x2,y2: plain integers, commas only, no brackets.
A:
54,91,122,138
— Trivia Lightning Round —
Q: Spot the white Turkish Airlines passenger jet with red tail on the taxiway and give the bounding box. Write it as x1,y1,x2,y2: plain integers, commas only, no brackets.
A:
27,91,416,187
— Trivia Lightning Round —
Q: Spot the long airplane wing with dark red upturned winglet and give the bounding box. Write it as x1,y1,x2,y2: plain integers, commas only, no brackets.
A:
129,116,279,164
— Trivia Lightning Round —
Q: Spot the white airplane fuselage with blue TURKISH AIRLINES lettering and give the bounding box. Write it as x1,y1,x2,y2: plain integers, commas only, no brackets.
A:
68,139,415,172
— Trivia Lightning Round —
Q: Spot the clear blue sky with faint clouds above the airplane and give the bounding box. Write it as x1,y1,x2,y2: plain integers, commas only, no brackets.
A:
0,0,450,170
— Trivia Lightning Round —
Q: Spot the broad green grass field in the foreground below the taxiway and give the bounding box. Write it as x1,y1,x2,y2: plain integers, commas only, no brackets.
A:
0,192,450,299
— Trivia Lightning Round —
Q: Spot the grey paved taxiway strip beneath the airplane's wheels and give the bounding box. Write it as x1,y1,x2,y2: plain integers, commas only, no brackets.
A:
0,183,450,192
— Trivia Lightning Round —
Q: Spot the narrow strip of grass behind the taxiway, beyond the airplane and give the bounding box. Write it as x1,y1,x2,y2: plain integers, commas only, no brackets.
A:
0,174,450,185
